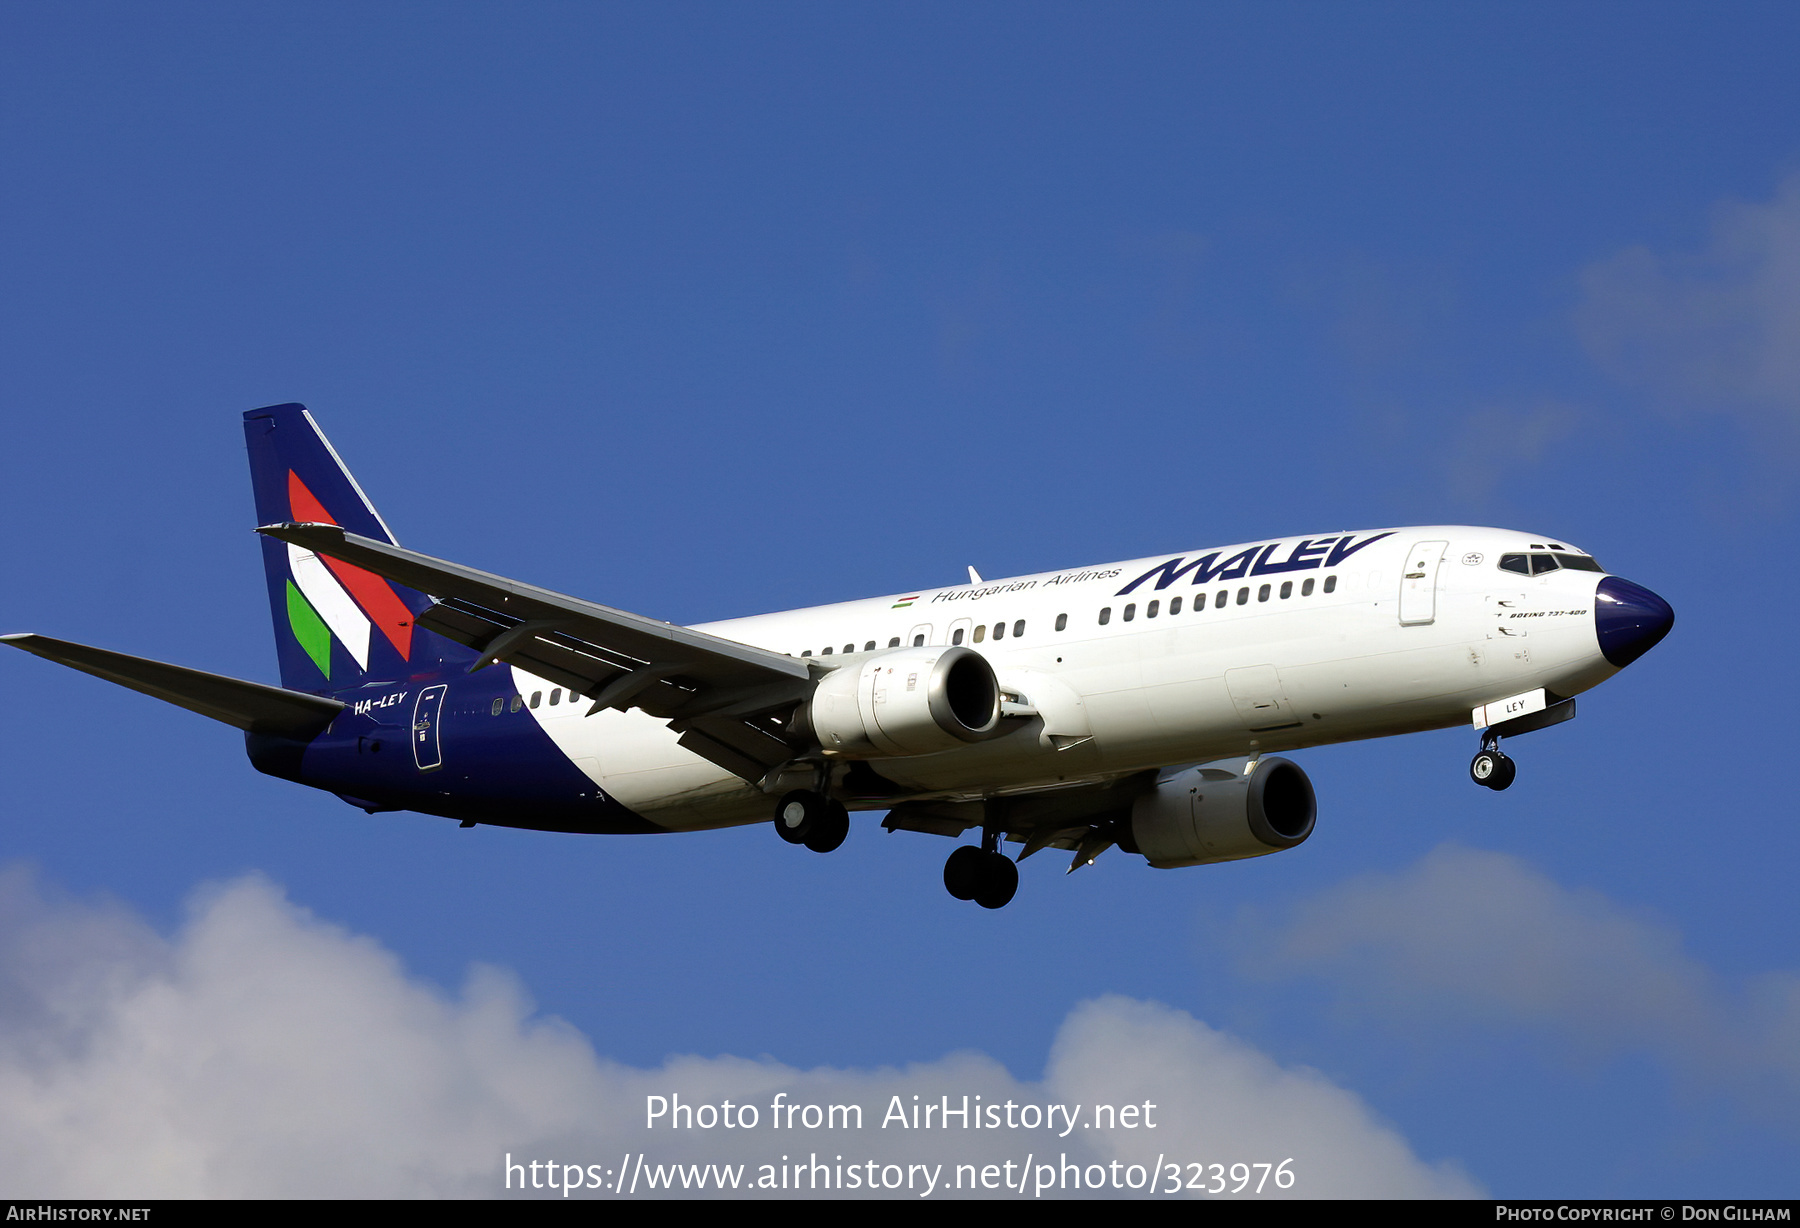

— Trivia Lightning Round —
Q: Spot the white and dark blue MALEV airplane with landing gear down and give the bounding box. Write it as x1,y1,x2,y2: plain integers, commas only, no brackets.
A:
0,403,1674,909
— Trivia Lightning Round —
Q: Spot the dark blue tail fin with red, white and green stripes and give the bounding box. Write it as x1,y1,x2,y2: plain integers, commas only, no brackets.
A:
243,405,475,693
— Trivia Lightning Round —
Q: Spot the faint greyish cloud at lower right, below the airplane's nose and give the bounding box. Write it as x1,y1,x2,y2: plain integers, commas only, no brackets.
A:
1246,844,1800,1118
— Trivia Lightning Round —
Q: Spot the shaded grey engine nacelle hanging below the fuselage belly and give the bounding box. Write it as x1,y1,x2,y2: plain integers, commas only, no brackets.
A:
1130,756,1319,870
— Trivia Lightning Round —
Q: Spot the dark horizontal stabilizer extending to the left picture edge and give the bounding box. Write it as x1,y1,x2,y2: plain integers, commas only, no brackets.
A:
0,634,344,740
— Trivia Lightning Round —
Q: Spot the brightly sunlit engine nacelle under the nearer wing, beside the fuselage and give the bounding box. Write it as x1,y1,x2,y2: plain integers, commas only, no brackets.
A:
794,645,1001,758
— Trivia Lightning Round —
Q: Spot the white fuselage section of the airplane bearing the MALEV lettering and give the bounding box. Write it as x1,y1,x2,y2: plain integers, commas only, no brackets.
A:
515,526,1616,830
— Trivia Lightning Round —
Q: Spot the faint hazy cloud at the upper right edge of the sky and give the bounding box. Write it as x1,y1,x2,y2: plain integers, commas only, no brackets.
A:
1575,175,1800,427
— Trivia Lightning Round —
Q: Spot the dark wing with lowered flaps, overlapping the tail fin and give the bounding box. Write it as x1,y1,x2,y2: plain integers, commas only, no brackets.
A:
257,524,814,780
